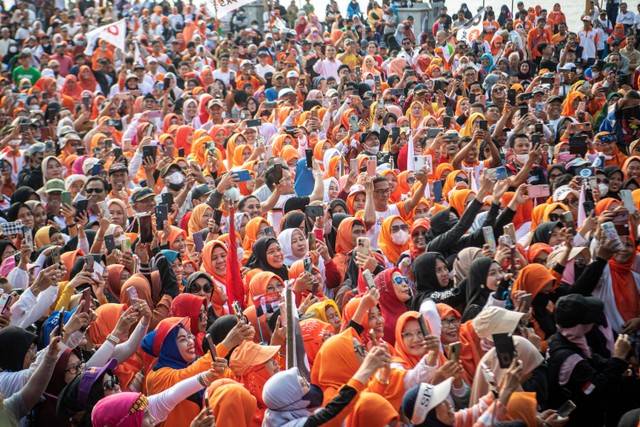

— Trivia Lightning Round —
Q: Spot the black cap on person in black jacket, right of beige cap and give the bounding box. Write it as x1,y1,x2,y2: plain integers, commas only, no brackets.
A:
554,294,606,328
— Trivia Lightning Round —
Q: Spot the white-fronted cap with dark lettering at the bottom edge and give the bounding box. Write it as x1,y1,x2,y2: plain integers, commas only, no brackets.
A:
402,378,453,425
